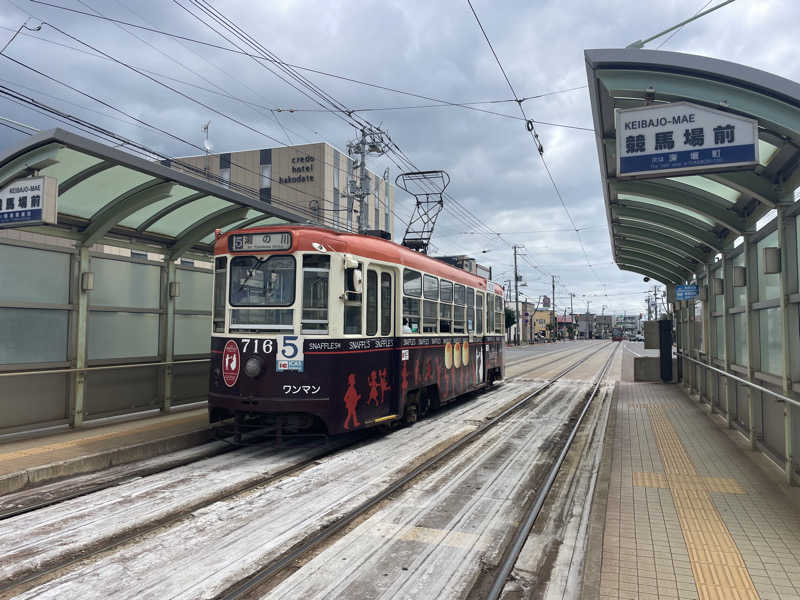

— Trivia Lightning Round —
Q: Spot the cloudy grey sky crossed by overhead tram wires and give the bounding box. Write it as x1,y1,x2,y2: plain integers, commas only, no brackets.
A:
0,0,800,314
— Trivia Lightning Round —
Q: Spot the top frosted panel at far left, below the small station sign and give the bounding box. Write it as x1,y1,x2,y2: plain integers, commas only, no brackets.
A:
0,245,69,304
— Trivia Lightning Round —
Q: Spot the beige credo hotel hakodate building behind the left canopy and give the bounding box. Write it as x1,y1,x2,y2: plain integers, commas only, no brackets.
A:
166,142,395,237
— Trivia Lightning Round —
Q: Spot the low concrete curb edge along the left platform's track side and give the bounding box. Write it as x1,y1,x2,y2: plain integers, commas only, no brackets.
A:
0,428,214,495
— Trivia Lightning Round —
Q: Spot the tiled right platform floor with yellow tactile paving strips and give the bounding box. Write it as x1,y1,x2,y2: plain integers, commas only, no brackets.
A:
584,382,800,600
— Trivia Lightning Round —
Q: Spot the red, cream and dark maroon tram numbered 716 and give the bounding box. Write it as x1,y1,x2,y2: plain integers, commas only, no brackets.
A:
208,226,505,434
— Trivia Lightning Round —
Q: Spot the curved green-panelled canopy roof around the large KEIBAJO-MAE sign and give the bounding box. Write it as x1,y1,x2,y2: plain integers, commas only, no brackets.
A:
585,49,800,284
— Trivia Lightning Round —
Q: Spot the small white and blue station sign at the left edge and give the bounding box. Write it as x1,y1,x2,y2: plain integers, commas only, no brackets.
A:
0,177,58,229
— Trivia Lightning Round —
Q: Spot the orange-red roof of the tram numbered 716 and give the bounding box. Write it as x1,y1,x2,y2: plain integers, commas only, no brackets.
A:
214,225,503,295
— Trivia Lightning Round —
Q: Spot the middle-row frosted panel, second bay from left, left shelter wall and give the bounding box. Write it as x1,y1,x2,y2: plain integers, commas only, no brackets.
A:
87,312,158,360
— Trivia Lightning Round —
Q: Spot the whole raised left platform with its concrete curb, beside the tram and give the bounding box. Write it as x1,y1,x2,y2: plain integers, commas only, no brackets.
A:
0,407,213,494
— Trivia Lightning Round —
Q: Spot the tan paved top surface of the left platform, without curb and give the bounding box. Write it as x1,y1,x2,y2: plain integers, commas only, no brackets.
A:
0,408,209,476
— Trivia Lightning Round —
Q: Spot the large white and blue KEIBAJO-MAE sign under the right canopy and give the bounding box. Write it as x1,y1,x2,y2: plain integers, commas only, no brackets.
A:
615,102,758,178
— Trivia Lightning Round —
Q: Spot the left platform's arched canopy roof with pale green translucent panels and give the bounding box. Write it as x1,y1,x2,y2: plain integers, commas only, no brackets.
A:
0,129,306,260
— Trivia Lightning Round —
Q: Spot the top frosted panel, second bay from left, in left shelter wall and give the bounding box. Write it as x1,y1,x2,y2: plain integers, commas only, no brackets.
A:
89,258,161,308
